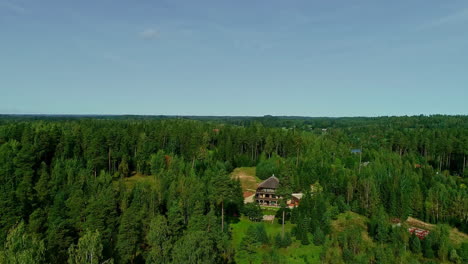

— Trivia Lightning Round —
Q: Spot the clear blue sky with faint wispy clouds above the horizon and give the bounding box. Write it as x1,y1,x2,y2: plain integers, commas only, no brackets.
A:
0,0,468,117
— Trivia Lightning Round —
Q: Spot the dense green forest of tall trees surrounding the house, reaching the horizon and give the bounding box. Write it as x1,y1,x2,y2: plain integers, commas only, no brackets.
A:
0,116,468,263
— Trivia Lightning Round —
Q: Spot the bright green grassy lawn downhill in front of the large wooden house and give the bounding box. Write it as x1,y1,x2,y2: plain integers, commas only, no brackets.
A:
231,217,322,264
